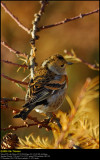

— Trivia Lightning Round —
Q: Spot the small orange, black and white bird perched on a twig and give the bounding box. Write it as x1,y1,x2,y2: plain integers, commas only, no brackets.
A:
14,54,72,120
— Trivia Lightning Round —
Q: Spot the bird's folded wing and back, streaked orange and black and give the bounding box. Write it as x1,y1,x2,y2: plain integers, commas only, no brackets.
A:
23,69,66,107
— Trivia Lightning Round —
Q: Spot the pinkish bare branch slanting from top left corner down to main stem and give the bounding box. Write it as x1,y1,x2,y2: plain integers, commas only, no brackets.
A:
1,2,30,34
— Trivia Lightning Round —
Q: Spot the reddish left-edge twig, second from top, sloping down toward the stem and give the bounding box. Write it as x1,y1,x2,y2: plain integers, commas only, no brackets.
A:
1,41,27,58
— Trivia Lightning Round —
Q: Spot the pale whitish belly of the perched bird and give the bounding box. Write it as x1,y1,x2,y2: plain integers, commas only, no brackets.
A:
34,87,67,113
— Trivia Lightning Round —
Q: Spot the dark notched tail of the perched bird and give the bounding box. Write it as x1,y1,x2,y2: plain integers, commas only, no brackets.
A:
13,106,34,120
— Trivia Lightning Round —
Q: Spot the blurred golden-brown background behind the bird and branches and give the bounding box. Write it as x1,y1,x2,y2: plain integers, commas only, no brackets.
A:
1,1,99,138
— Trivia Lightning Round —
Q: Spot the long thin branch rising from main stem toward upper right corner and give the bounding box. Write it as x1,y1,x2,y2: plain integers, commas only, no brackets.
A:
38,9,100,31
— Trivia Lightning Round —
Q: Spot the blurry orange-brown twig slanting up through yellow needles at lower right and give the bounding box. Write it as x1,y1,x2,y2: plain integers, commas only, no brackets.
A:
54,78,91,149
